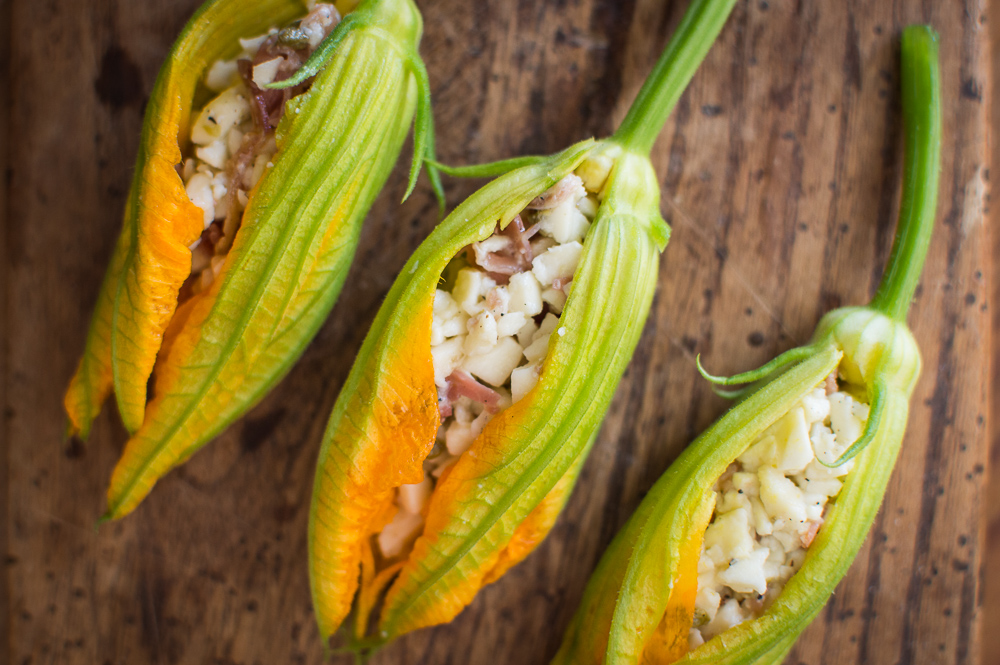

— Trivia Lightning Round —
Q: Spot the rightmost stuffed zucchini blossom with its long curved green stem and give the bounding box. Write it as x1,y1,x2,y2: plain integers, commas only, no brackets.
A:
553,26,941,665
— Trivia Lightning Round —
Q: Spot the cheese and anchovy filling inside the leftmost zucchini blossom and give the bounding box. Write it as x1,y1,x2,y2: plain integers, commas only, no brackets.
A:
184,3,340,302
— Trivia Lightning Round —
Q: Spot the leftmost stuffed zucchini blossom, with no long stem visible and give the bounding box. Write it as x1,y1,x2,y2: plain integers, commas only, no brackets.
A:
65,0,440,519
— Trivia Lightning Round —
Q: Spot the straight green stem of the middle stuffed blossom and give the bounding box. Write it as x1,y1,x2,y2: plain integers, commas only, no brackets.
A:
614,0,736,155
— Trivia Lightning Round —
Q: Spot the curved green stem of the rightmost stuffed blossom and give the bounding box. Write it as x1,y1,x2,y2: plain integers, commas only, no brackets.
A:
871,25,941,322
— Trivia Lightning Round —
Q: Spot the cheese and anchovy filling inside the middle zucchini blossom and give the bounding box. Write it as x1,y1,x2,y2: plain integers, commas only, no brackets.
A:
378,170,610,559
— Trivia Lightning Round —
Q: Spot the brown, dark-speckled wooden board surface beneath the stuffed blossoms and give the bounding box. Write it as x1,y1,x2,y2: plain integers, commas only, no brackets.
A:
0,0,988,665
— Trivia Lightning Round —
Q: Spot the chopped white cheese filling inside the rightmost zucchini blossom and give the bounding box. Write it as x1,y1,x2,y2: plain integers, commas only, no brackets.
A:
689,375,868,649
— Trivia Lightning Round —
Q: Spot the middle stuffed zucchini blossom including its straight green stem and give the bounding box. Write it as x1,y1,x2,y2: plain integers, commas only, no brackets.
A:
309,0,735,651
